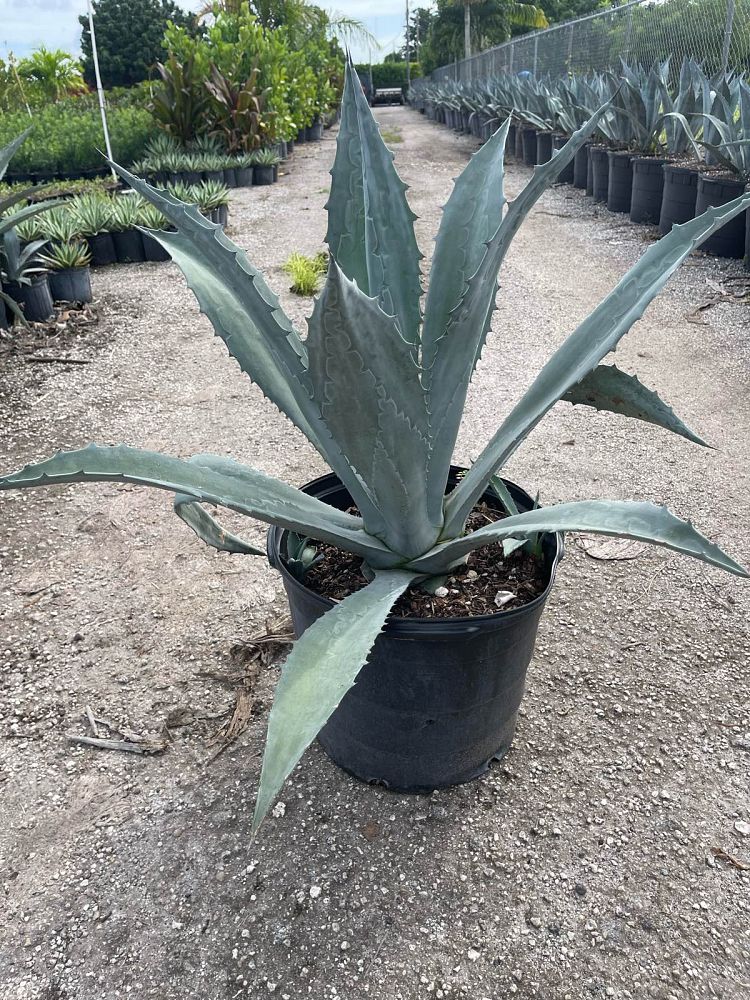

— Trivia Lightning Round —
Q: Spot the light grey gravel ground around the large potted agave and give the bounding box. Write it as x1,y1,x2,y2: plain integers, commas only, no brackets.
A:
0,108,750,1000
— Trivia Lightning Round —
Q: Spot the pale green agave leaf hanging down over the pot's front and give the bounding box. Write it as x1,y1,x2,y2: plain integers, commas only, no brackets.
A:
253,570,415,833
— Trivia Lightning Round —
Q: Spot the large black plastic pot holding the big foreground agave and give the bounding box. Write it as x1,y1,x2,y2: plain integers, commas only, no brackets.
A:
268,469,562,793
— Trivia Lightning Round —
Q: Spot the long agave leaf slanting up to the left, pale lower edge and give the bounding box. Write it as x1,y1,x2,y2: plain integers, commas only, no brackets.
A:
112,163,388,525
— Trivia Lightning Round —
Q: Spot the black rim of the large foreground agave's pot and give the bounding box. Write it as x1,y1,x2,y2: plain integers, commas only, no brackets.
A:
266,466,565,634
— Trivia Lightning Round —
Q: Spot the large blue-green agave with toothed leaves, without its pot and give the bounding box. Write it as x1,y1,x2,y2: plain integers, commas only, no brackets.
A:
0,66,750,829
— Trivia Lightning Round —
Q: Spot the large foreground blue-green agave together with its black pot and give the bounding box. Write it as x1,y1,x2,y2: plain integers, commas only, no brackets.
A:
0,66,750,829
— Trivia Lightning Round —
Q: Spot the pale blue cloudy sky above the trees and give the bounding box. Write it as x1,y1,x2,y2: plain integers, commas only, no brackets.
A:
0,0,416,62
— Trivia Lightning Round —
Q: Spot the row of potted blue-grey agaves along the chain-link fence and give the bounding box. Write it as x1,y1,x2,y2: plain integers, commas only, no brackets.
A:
410,60,750,266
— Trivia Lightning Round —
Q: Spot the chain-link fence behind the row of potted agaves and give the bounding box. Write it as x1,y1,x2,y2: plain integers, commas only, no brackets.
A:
432,0,750,82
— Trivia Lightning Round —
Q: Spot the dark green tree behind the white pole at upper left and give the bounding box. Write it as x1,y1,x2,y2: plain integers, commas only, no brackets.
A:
78,0,195,88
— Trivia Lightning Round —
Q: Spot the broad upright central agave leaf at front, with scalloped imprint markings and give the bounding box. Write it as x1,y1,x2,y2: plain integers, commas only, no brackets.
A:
306,258,434,556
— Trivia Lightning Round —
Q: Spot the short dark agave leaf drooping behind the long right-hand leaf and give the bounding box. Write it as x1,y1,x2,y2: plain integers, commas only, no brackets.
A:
564,365,708,446
